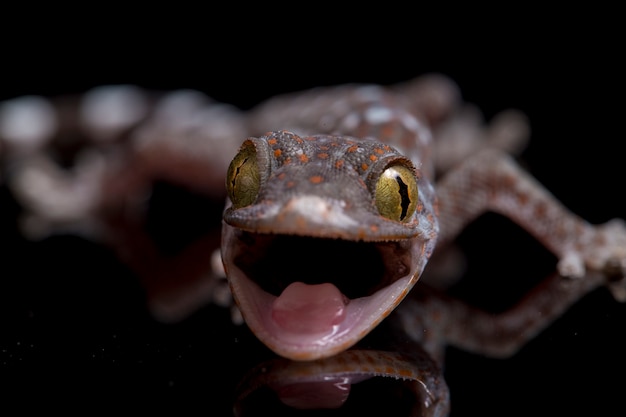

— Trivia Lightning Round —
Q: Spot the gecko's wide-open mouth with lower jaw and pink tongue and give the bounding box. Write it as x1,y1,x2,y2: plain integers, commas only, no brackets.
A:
222,223,423,360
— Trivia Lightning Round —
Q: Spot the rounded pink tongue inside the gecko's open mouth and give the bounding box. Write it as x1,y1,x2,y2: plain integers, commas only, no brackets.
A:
272,282,348,333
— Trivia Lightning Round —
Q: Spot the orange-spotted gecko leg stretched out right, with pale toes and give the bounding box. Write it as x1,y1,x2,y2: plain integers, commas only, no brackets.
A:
437,151,626,290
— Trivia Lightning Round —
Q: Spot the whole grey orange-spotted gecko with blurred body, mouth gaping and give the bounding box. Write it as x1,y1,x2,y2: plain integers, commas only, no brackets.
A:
0,75,626,412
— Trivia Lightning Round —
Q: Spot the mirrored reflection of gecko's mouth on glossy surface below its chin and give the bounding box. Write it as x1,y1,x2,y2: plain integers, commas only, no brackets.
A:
235,350,448,416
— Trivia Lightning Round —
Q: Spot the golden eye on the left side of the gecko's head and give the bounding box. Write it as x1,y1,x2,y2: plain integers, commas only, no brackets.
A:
226,142,261,208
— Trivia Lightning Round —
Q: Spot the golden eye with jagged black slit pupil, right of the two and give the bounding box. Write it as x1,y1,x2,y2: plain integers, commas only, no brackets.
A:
374,165,417,222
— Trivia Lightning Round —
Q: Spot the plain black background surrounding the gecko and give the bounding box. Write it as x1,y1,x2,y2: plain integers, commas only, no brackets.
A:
0,9,626,417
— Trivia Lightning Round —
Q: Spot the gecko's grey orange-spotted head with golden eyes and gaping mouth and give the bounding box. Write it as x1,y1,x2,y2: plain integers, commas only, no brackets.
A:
222,132,437,360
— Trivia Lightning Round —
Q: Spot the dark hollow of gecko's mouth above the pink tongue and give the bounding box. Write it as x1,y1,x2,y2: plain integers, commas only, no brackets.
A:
234,232,409,299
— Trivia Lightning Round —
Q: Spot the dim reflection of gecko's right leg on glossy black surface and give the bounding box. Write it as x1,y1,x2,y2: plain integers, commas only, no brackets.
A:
399,271,605,361
